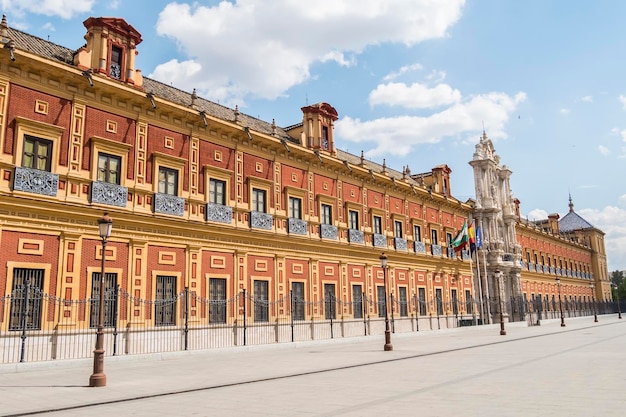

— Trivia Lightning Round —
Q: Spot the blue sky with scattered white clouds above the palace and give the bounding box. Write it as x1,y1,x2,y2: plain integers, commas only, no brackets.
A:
0,0,626,271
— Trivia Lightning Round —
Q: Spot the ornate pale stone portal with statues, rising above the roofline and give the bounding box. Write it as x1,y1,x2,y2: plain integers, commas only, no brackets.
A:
469,132,522,322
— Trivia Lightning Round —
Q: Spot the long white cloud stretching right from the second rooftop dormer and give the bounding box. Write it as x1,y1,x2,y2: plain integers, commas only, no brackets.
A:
335,93,526,158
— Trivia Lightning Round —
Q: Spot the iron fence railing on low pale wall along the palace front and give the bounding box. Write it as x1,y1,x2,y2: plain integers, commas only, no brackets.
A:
0,285,618,363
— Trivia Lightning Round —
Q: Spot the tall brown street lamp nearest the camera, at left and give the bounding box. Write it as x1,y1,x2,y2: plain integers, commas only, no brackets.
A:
89,213,113,387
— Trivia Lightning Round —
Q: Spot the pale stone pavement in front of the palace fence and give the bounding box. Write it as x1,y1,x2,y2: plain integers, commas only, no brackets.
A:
0,315,626,417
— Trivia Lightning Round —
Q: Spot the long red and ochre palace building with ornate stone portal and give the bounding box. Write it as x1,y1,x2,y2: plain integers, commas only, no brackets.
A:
0,17,610,358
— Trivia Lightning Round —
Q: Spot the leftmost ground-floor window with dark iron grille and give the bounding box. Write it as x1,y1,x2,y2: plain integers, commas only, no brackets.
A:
9,268,44,330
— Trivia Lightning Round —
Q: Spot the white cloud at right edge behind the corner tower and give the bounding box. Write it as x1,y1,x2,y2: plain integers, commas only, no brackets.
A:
577,205,626,272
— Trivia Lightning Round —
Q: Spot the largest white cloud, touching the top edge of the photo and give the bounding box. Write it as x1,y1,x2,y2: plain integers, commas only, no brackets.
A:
149,0,465,102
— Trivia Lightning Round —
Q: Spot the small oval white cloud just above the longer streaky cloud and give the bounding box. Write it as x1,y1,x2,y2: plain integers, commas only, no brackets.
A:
369,83,461,109
